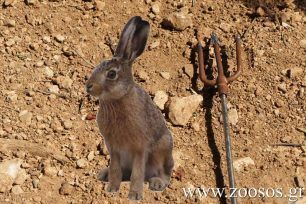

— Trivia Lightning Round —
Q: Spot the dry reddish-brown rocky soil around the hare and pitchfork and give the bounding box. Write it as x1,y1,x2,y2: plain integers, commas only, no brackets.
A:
0,0,306,203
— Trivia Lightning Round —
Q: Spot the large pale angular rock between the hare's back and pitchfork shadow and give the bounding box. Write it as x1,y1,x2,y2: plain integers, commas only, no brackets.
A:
169,94,203,126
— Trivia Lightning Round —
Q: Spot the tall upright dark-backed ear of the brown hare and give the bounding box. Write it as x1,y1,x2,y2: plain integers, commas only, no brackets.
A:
114,16,150,61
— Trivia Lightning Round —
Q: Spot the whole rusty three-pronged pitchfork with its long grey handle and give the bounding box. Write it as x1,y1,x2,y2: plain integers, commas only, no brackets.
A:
197,31,241,204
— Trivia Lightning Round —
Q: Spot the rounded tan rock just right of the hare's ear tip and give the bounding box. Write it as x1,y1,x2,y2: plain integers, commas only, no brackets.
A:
163,11,192,31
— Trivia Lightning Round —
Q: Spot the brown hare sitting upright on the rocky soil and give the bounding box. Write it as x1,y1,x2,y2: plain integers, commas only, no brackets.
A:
86,16,173,200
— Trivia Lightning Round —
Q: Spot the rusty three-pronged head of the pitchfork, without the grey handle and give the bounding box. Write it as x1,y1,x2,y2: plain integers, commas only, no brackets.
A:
198,33,242,94
